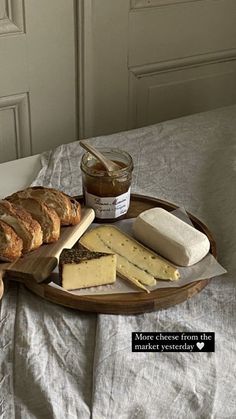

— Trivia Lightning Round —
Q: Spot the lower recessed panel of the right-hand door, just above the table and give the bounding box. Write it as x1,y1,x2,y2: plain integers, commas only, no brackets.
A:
130,61,236,127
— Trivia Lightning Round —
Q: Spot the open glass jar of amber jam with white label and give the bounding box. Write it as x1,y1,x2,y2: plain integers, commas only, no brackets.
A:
80,148,133,222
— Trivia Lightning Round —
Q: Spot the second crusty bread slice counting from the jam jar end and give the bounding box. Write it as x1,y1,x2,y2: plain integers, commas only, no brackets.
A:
7,193,60,243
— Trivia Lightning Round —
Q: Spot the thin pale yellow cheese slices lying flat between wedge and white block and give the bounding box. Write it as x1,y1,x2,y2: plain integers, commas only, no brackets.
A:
80,225,180,292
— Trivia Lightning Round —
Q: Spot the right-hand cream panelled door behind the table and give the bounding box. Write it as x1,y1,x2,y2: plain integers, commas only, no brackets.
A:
81,0,236,137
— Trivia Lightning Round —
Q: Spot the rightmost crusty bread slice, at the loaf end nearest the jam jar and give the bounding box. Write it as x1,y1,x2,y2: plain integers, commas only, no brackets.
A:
6,186,81,225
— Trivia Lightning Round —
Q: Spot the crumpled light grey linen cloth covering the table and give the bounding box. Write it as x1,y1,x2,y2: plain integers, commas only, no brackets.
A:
0,106,236,419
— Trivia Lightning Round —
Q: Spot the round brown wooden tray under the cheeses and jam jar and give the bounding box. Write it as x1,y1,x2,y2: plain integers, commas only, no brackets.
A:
19,195,216,314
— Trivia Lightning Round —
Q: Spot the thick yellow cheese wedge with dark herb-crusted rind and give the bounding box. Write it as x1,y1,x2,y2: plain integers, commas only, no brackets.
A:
59,249,116,290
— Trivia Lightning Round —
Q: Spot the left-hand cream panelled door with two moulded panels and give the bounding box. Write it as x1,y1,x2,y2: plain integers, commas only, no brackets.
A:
0,0,77,162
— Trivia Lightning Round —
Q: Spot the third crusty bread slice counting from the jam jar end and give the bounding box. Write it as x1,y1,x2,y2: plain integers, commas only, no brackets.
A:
0,200,42,253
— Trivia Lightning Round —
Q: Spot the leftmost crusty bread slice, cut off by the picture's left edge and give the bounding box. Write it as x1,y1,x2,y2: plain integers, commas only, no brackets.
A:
0,220,23,262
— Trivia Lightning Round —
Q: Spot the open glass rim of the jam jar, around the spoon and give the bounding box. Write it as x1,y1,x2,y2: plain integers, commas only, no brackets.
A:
80,147,134,177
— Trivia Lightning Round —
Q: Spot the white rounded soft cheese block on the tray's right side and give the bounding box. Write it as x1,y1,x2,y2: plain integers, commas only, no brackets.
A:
133,208,210,266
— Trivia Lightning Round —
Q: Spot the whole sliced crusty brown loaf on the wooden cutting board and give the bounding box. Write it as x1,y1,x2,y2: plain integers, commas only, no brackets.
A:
0,187,81,261
